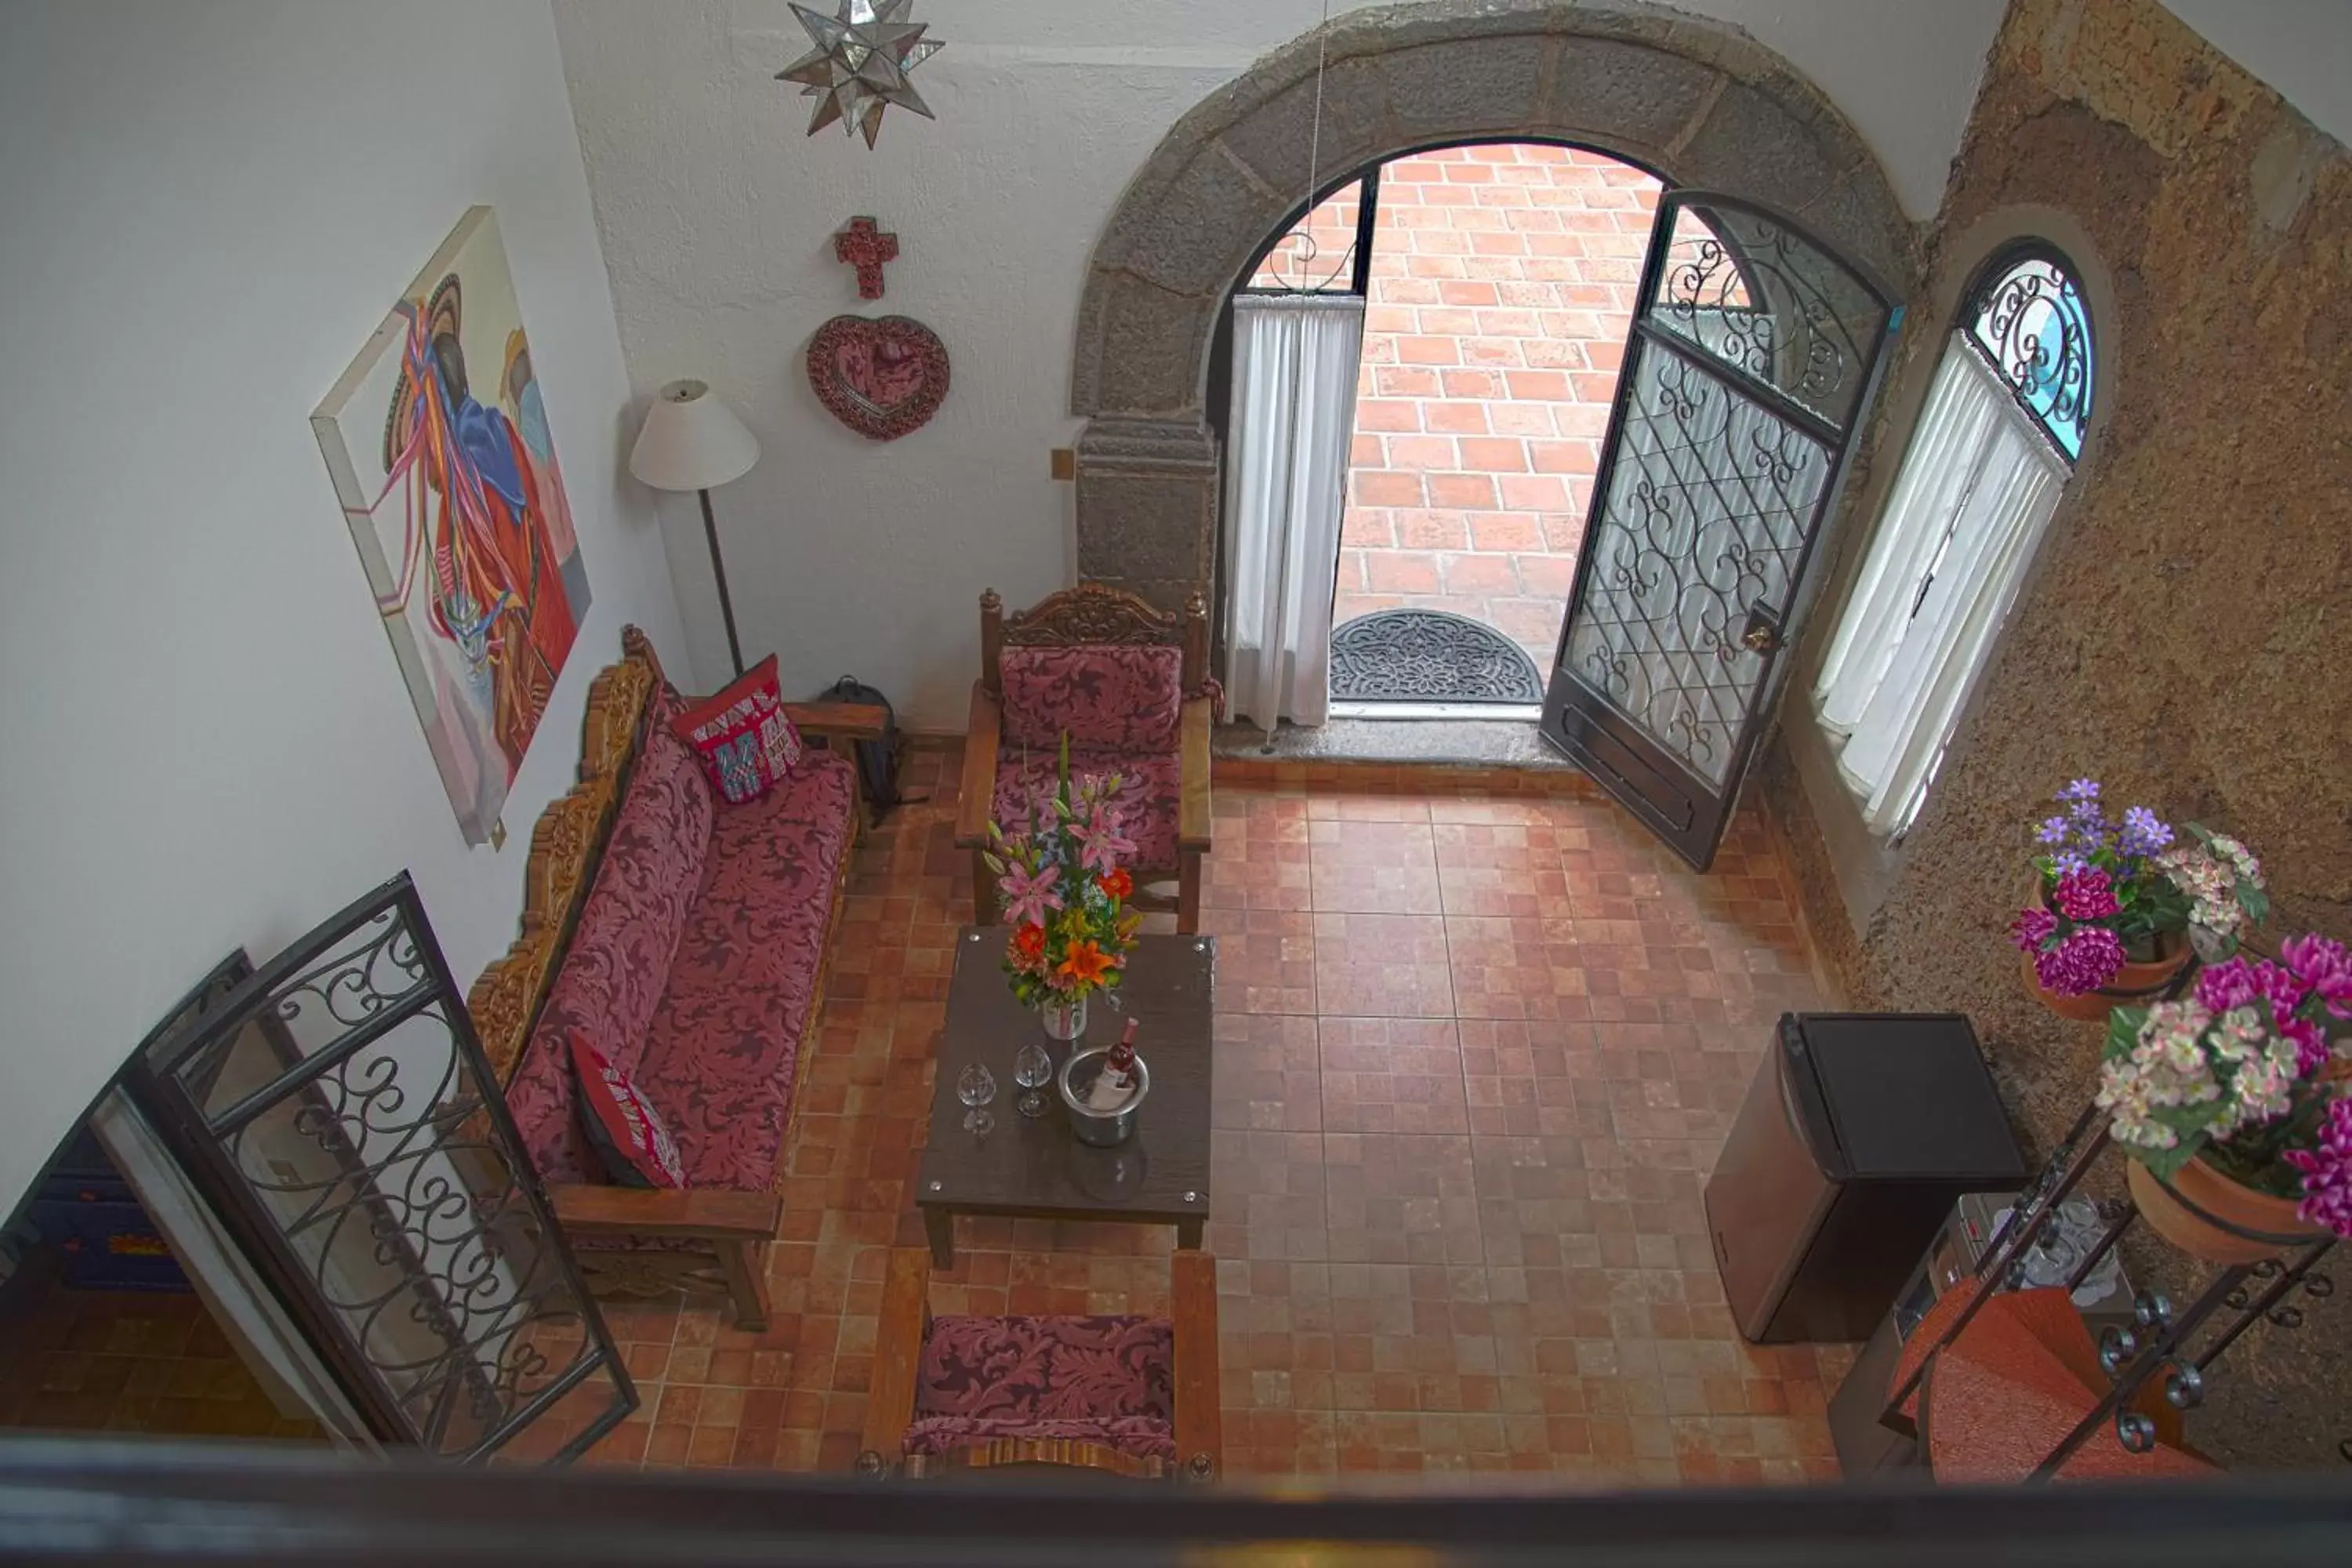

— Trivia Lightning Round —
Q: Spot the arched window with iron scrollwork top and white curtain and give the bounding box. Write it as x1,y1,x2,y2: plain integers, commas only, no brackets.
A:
1813,242,2096,834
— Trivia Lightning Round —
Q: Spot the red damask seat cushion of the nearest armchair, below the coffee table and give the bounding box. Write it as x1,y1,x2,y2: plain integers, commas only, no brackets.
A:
906,1316,1176,1460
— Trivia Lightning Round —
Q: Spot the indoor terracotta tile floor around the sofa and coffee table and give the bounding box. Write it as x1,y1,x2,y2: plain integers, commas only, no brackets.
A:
548,750,1849,1483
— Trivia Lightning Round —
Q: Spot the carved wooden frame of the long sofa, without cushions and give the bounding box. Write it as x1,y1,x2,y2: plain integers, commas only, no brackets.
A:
466,626,887,1328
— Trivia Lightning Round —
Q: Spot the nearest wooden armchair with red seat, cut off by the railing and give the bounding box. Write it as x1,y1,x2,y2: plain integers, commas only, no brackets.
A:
856,1248,1225,1481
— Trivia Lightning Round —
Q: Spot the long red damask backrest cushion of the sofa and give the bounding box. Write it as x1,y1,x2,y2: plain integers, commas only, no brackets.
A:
506,694,715,1182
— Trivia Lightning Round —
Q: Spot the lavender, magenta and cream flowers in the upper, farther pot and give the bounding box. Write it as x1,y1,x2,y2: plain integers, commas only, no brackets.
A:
2009,779,2270,996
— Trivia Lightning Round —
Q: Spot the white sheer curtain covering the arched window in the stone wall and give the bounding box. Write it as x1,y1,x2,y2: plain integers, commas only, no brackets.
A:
1813,339,2067,832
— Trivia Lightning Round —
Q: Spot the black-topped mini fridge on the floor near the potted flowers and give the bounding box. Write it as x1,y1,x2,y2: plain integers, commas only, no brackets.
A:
1705,1013,2027,1345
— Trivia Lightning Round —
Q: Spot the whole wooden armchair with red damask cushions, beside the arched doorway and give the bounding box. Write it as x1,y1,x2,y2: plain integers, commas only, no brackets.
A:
955,583,1216,931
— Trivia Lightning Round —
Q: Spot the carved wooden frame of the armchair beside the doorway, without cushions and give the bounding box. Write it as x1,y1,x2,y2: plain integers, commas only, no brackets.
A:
955,583,1216,933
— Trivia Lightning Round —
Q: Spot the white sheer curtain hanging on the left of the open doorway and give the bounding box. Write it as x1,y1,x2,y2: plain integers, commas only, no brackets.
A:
1225,294,1364,734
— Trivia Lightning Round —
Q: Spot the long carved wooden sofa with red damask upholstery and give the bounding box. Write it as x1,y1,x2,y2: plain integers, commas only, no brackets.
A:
468,628,884,1328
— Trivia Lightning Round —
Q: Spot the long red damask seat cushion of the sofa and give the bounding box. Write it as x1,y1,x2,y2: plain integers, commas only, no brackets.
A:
637,753,851,1192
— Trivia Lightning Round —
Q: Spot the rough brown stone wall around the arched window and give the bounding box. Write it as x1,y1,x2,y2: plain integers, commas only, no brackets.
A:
1764,0,2352,1469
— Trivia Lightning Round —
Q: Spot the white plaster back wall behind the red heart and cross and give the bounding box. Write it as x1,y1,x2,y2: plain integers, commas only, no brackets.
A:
555,0,2002,729
